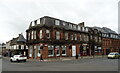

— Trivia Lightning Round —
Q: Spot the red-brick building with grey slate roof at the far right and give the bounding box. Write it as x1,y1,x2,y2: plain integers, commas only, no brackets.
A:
93,27,120,55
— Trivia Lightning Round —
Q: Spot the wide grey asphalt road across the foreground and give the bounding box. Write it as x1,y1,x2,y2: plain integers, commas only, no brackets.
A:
2,58,118,71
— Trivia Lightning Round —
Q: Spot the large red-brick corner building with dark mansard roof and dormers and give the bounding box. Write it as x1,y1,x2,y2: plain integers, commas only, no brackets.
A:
26,16,102,59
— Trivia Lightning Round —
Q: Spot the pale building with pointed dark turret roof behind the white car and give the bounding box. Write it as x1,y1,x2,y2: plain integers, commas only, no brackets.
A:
6,34,28,56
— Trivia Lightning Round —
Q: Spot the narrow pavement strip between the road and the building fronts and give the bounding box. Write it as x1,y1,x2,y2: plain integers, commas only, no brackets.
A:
3,55,107,62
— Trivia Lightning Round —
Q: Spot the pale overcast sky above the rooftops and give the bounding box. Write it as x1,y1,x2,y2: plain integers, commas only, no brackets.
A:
0,0,119,42
